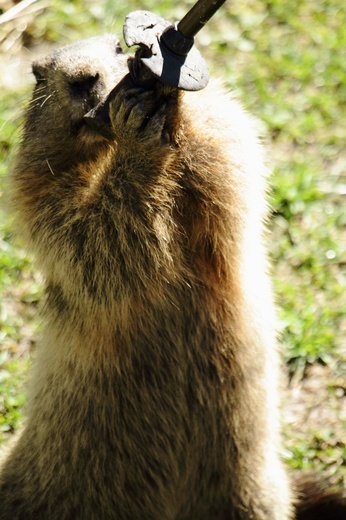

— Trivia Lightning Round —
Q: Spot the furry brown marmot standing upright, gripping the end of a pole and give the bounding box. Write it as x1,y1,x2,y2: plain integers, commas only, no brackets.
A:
0,35,344,520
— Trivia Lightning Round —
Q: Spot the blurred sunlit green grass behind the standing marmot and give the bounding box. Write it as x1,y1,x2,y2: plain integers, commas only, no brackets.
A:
0,0,346,480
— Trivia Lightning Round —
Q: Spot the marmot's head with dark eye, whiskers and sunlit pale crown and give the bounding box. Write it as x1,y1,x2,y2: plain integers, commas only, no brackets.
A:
24,34,128,169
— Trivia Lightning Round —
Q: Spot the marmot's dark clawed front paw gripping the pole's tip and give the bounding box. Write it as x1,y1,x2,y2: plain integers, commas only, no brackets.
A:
109,88,170,147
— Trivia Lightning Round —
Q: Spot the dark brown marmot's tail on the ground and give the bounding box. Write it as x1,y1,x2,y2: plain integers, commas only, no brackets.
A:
295,477,346,520
